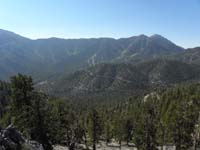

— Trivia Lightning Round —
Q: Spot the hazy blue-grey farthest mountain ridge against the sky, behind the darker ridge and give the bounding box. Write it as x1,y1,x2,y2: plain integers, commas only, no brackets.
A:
0,30,184,80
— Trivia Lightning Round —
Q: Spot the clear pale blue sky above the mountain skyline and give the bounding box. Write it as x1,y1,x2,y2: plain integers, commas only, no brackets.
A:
0,0,200,47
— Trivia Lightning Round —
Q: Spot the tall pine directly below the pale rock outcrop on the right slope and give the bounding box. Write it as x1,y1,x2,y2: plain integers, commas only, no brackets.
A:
134,96,158,150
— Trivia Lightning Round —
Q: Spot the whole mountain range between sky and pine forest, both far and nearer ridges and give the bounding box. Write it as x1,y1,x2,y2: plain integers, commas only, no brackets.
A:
0,30,200,97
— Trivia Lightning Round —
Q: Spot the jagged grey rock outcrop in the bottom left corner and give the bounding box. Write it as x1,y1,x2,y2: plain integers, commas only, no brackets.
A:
0,125,44,150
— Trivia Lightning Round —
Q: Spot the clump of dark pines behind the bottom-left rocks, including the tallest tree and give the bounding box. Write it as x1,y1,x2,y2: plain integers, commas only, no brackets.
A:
8,74,52,150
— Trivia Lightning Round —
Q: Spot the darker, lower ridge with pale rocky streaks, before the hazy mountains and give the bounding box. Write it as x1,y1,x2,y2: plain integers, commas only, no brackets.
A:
38,59,200,95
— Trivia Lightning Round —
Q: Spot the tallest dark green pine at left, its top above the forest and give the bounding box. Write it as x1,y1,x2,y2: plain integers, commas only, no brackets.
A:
11,74,34,136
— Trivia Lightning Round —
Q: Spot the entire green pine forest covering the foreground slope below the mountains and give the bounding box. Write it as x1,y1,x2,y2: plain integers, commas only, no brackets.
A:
0,74,200,150
